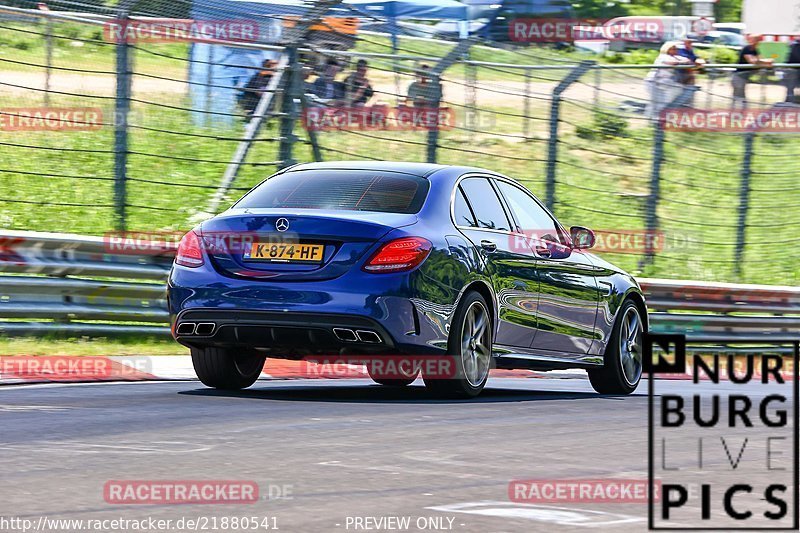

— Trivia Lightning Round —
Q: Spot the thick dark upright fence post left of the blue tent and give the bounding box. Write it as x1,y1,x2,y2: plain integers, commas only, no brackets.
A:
114,13,131,231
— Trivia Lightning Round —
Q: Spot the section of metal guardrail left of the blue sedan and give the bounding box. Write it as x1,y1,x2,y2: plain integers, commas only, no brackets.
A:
0,231,174,336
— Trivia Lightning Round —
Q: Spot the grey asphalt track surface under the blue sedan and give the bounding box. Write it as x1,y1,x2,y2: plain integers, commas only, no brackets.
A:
0,379,792,533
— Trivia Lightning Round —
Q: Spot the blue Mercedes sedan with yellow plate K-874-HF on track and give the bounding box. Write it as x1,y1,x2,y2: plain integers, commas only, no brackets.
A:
168,161,648,397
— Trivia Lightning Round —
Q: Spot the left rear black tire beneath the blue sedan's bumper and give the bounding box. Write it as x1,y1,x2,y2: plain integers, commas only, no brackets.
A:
191,348,266,390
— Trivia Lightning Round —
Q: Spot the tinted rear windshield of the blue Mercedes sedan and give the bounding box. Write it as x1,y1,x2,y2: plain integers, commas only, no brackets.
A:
236,170,428,213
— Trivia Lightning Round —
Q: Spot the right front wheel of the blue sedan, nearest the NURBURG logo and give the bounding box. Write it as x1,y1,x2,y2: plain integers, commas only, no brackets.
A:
588,300,645,394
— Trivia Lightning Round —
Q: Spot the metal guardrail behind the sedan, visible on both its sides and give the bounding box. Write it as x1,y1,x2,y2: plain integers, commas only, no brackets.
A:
0,231,800,342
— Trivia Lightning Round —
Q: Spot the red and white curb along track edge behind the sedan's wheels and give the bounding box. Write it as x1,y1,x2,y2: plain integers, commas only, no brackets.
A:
0,355,586,385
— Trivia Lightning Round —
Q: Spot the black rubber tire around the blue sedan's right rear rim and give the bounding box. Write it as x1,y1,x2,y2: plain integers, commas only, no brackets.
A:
422,291,494,398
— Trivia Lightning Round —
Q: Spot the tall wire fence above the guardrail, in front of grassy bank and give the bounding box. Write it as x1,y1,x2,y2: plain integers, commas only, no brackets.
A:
0,0,800,284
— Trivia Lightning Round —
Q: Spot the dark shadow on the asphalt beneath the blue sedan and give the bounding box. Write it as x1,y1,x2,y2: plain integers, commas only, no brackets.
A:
178,385,628,404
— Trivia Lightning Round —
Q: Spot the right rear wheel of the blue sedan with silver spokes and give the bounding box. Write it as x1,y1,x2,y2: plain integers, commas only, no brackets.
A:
423,292,493,398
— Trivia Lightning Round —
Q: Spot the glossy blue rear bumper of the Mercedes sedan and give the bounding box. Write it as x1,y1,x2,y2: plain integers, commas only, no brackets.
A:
167,265,457,357
